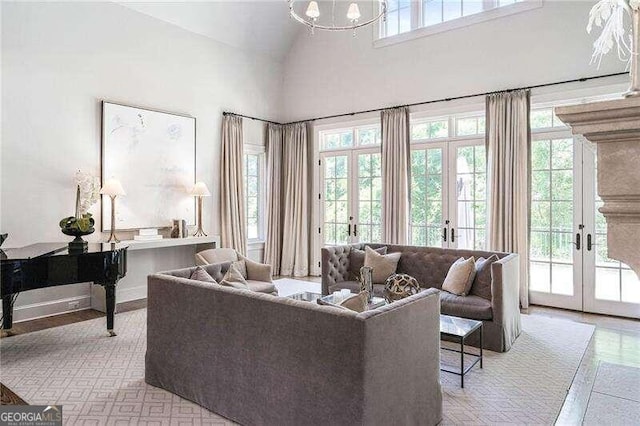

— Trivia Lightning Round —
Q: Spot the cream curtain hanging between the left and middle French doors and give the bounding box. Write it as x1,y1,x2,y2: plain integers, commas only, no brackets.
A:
381,108,411,244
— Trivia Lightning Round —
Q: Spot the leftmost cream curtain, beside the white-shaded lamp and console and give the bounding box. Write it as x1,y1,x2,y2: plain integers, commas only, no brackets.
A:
220,115,247,255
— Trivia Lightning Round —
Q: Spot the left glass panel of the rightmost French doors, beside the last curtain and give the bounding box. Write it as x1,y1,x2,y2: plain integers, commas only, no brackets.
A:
529,138,582,309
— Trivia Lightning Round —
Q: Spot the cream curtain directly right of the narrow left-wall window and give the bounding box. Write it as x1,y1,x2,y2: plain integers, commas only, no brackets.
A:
264,124,284,275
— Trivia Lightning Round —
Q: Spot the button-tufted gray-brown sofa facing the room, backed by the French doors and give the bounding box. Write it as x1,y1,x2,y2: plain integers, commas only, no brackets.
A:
322,244,521,352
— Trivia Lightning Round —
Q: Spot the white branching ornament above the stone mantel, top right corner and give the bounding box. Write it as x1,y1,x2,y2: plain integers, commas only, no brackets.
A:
587,0,640,98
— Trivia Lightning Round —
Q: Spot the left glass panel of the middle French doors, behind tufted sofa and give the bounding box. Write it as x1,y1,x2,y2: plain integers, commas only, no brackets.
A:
409,144,447,247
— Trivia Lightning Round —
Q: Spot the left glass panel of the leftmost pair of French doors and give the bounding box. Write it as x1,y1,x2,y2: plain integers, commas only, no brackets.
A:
322,154,351,245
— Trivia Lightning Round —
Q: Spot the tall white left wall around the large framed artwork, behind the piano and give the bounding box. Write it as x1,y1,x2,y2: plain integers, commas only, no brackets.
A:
0,2,283,319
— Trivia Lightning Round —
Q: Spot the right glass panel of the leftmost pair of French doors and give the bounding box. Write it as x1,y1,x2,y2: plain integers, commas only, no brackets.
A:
353,150,382,243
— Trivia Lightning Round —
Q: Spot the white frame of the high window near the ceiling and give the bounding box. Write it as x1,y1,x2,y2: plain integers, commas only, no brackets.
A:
373,0,544,48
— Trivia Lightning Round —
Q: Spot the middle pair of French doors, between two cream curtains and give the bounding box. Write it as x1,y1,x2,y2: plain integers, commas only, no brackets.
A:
410,139,486,249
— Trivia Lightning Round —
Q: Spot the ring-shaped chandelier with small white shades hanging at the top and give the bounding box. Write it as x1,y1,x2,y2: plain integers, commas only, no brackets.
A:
288,0,387,36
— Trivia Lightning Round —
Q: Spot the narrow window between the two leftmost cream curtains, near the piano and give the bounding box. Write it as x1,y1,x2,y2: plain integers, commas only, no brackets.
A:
244,152,264,241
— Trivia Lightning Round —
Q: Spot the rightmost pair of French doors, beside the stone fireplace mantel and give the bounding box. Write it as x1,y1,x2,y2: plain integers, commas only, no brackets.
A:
529,133,640,318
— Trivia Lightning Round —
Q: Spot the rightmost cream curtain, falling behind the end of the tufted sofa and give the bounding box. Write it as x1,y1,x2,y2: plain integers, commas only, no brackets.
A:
486,90,531,308
